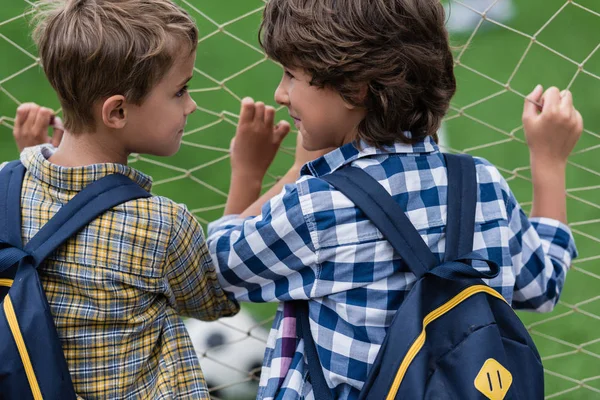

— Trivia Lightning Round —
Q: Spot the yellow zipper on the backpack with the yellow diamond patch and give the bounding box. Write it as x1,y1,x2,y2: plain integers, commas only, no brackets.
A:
386,285,506,400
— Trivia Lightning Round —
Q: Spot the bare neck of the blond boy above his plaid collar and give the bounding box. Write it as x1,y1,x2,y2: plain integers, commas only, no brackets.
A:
48,132,129,167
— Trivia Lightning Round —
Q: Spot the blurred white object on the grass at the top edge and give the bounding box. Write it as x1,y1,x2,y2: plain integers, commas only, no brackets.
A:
444,0,515,33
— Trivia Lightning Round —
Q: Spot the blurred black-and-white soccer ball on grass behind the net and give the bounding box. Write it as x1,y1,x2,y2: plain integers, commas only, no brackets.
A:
185,310,268,400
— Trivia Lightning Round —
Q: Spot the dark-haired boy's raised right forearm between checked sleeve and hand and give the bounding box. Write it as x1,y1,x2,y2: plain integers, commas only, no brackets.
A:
531,157,567,224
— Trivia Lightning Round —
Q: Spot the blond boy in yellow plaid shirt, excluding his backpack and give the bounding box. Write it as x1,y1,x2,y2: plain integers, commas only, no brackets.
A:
1,0,244,399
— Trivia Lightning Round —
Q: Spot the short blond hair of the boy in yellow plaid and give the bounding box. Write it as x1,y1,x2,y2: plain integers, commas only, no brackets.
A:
33,0,198,133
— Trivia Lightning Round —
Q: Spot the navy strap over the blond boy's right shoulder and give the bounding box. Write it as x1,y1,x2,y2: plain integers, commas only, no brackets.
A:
25,174,151,268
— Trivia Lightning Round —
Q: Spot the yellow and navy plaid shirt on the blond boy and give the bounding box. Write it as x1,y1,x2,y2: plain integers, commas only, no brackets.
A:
0,146,239,399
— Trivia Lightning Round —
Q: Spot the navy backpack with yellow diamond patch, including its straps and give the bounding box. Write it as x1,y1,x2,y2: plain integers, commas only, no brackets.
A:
296,154,544,400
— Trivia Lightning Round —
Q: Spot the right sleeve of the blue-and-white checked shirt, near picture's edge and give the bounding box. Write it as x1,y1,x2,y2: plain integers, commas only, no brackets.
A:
503,181,577,312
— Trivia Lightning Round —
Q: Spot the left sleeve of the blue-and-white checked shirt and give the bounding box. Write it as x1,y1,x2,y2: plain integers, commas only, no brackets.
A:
208,184,319,302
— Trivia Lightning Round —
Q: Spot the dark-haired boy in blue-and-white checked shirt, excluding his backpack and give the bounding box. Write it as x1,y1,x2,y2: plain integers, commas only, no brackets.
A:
207,0,582,400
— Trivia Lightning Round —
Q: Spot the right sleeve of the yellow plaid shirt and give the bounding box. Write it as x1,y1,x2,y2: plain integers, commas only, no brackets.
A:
164,206,239,321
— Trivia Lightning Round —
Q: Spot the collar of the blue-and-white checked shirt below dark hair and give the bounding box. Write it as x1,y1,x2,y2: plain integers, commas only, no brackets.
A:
300,136,439,177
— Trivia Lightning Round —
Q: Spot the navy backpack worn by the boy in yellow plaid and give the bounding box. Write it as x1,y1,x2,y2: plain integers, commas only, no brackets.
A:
0,161,150,400
